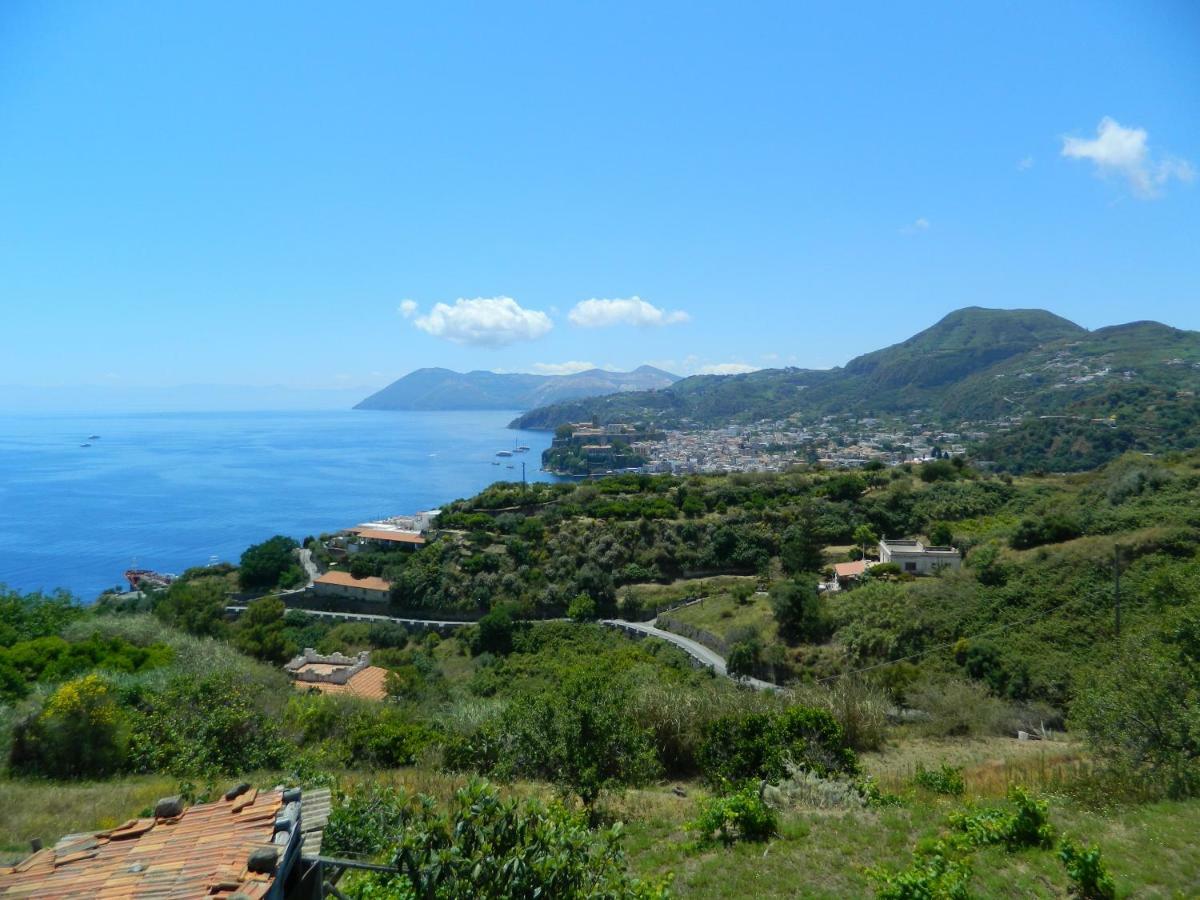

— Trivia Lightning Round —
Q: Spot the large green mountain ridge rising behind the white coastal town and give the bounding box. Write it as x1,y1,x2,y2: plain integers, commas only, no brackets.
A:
512,307,1200,468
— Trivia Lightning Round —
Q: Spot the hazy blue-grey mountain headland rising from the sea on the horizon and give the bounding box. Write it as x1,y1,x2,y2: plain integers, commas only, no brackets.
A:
354,366,679,409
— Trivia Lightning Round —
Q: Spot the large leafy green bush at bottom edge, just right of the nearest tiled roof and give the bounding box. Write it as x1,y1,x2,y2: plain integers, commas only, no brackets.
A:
325,781,668,900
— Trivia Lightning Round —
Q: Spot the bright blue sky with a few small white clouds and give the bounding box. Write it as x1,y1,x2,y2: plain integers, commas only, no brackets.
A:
0,0,1200,400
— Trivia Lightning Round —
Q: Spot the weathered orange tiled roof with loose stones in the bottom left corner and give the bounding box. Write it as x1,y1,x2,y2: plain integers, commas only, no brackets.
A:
0,790,283,900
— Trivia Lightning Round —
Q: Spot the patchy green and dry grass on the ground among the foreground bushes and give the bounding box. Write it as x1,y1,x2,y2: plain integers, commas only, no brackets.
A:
0,736,1200,898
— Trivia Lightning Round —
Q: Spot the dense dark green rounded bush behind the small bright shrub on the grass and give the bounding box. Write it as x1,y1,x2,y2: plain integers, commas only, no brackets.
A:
698,707,858,785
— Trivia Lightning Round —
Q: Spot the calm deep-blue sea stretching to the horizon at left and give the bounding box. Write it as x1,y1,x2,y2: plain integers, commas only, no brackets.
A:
0,410,553,601
